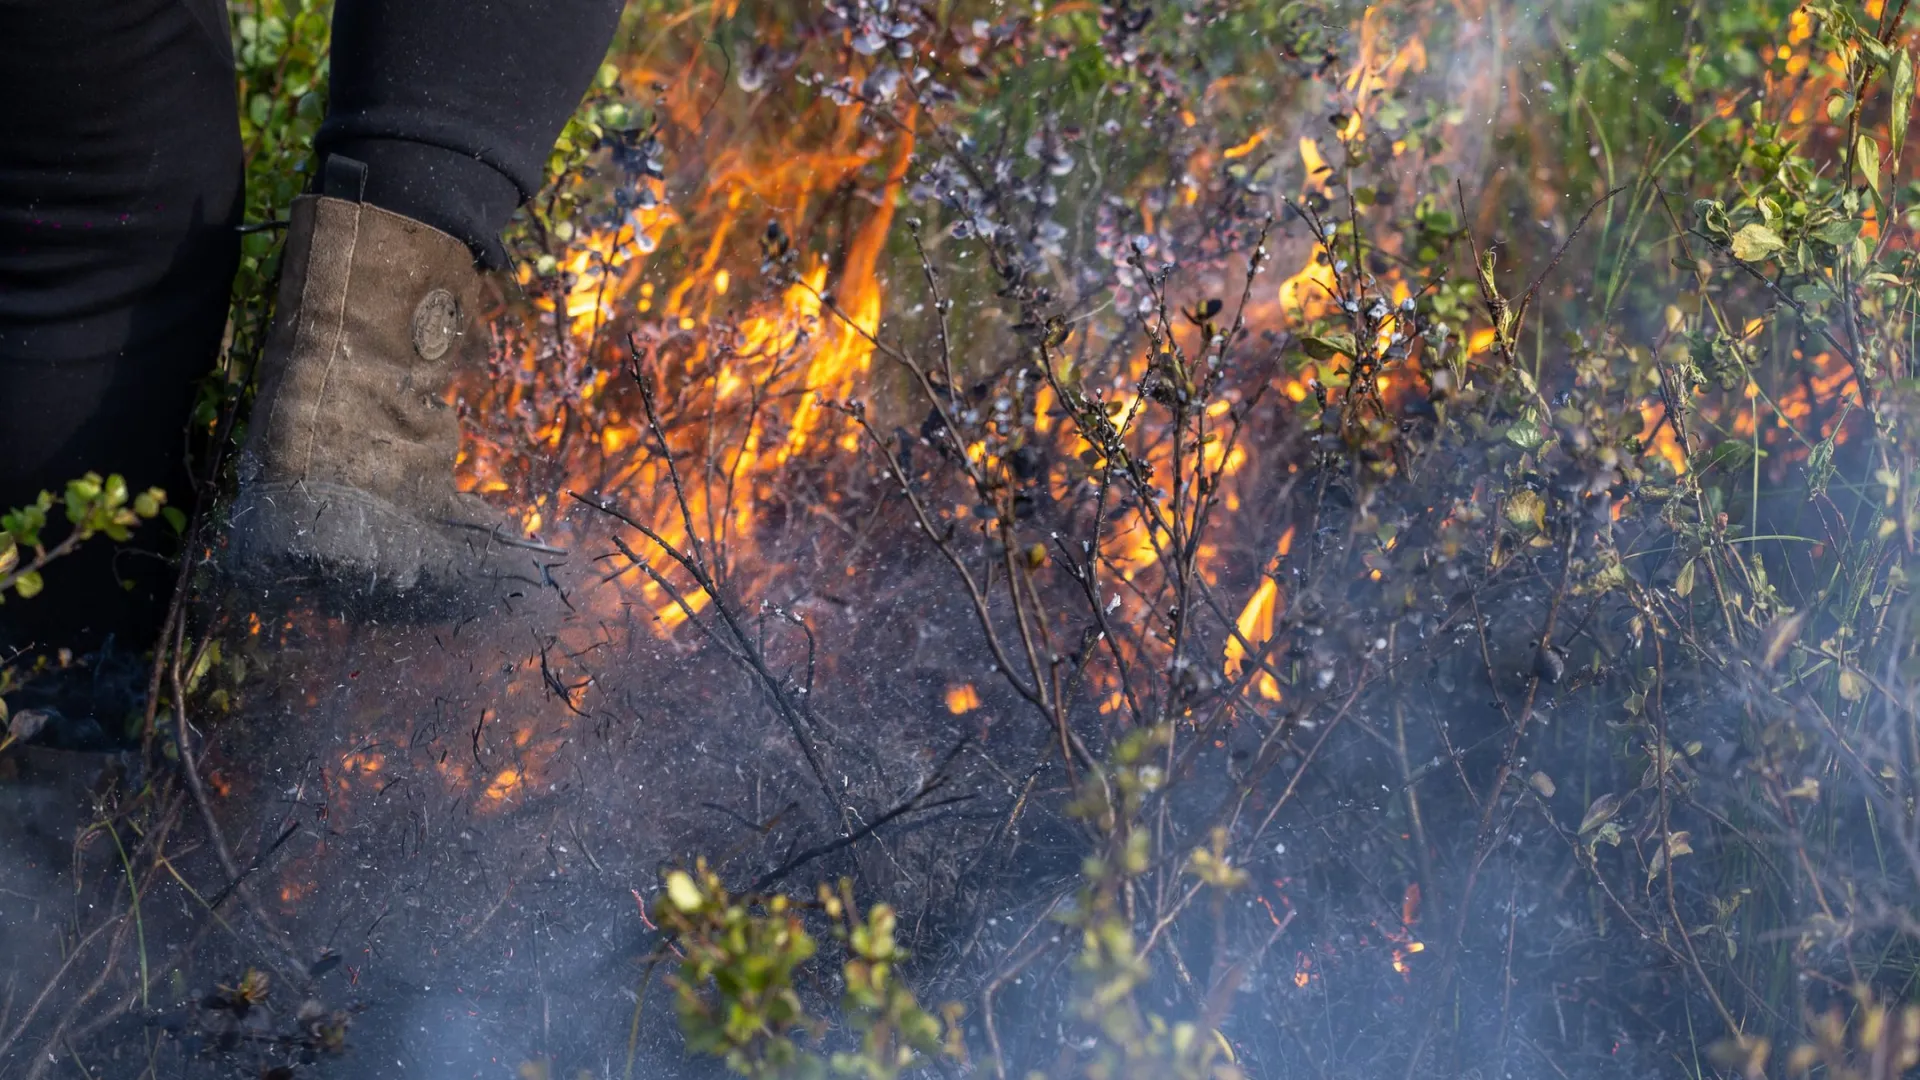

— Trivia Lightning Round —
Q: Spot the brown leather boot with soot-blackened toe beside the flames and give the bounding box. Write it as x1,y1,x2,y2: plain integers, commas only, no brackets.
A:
228,158,563,617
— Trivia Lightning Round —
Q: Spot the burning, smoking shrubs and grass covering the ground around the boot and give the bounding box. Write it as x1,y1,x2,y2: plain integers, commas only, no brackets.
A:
0,0,1920,1078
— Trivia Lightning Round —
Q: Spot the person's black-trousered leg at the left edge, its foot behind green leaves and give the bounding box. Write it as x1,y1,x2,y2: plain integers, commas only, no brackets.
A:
0,0,242,657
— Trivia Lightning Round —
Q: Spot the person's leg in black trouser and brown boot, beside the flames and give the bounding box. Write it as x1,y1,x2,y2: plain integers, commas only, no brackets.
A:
228,0,622,619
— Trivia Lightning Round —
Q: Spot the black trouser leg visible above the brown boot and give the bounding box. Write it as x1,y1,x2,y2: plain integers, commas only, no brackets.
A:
317,0,622,267
